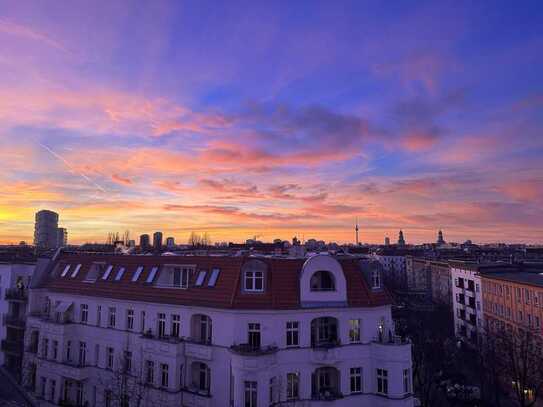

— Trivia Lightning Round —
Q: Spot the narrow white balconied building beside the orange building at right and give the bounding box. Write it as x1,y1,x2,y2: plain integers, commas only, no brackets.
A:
450,262,484,343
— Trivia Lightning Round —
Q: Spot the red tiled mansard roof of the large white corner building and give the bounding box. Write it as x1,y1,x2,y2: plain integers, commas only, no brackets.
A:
45,253,391,309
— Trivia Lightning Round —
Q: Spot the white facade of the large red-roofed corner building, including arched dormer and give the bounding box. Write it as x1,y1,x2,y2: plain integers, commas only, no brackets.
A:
24,255,413,407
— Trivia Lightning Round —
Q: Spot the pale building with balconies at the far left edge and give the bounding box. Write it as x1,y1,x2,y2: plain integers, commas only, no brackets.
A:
0,261,35,378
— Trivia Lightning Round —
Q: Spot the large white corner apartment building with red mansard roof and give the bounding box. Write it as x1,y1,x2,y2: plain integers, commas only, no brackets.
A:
23,253,413,407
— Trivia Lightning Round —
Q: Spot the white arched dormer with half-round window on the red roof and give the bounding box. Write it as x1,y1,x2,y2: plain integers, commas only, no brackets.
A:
300,254,347,307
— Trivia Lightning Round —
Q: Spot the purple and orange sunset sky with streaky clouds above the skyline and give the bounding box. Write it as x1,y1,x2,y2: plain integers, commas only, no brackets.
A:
0,0,543,243
